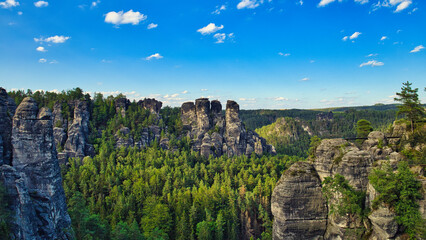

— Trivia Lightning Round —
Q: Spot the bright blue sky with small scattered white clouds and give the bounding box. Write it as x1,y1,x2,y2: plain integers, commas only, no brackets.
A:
0,0,426,109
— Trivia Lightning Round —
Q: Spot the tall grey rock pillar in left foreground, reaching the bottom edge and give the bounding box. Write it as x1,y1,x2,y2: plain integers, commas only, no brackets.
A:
0,98,71,239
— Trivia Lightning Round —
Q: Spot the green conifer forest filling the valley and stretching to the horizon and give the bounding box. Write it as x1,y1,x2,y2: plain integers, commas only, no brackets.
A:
2,88,422,239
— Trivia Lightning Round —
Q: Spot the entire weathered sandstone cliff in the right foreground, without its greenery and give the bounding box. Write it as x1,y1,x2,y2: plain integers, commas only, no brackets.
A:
272,132,412,240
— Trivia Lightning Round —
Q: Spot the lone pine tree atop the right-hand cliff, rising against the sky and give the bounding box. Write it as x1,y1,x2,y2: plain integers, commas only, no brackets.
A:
394,81,424,132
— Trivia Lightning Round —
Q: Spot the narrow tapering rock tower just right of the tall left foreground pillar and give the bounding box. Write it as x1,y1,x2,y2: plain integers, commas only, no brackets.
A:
59,101,94,163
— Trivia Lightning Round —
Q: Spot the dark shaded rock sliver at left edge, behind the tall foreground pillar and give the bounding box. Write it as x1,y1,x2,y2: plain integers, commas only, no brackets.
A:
0,88,16,165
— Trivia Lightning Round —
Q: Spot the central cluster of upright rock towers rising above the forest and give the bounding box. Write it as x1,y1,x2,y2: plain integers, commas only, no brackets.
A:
181,98,275,157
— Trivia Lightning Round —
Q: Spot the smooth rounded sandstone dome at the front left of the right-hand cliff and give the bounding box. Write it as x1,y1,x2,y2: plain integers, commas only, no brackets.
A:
271,162,328,240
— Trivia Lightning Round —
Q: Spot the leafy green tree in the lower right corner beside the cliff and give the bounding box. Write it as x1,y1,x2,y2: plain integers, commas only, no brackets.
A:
369,162,426,239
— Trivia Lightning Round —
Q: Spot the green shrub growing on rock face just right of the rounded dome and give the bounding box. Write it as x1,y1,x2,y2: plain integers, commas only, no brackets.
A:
322,174,365,219
